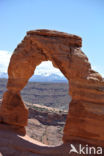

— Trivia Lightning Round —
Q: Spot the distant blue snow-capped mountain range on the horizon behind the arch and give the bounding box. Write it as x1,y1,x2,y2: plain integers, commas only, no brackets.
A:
0,72,68,83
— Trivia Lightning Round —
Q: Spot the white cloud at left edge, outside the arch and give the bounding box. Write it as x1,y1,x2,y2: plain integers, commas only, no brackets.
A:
0,50,11,72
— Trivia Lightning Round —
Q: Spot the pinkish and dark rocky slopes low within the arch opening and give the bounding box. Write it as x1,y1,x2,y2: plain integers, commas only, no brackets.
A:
26,103,68,145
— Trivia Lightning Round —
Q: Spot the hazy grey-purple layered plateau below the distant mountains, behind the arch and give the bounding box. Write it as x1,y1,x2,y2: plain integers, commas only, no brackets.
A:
0,79,71,110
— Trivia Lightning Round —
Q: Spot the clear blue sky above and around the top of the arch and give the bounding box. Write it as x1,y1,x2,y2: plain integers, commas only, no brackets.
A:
0,0,104,75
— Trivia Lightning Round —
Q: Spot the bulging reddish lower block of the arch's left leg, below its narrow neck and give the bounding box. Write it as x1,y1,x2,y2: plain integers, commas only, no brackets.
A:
0,91,28,134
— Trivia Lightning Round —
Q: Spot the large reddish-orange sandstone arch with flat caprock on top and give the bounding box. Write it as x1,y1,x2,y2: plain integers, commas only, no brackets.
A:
0,30,104,145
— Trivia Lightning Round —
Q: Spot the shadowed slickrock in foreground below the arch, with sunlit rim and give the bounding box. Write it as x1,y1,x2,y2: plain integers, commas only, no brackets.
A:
0,124,104,156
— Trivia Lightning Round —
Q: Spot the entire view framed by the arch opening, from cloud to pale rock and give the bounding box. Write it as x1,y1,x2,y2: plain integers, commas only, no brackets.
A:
22,61,71,145
